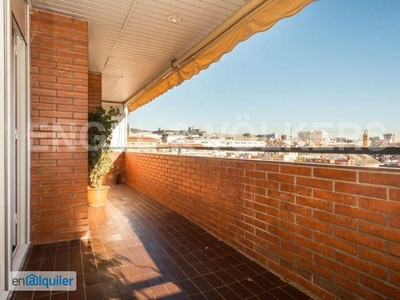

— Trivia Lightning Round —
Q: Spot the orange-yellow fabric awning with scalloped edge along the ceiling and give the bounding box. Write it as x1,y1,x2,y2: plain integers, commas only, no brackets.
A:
126,0,315,112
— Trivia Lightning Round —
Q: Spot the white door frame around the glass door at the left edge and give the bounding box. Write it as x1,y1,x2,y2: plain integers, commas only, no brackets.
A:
0,0,30,300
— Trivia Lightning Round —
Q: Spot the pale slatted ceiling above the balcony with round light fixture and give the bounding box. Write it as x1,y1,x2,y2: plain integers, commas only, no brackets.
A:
31,0,249,103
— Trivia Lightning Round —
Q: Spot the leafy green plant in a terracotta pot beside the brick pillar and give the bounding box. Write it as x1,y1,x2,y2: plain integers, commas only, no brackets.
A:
88,106,120,207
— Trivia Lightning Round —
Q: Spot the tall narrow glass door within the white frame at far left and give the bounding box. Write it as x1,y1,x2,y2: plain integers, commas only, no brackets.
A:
8,20,29,270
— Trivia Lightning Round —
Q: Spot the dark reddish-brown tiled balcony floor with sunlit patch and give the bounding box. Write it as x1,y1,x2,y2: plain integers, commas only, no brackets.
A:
12,184,311,300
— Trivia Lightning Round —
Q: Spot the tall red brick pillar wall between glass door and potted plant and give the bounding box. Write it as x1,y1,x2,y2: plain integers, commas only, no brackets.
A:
30,10,88,244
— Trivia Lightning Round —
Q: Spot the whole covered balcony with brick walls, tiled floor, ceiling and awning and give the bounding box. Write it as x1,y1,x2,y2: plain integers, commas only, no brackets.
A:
0,0,400,300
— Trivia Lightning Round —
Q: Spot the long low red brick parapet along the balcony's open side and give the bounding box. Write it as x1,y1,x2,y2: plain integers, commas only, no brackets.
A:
125,153,400,300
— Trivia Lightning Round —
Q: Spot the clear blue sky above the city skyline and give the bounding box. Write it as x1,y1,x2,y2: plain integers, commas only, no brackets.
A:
128,0,400,140
